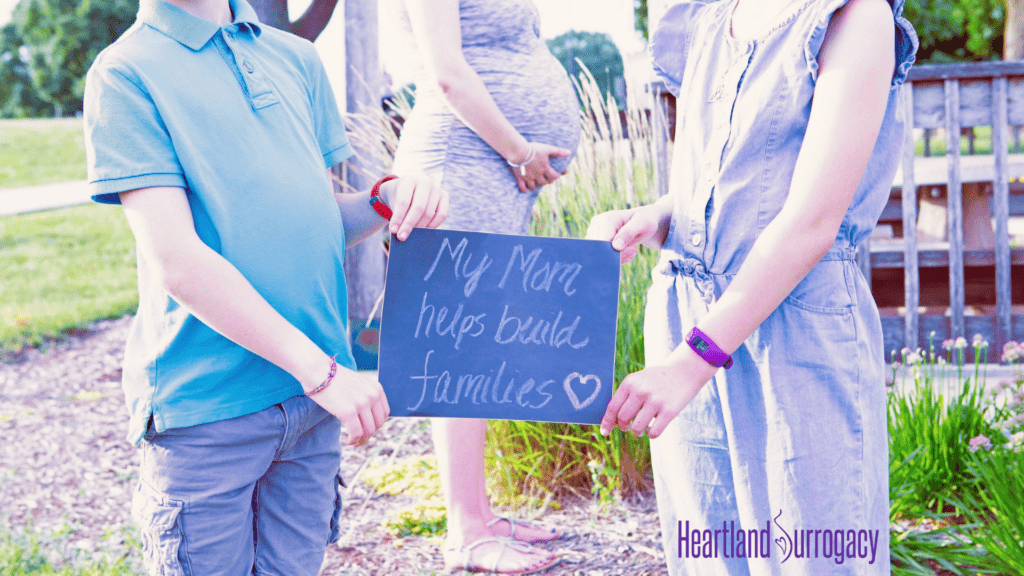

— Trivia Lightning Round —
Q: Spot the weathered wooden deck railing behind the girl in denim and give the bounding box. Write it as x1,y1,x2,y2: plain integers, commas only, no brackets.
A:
649,60,1024,361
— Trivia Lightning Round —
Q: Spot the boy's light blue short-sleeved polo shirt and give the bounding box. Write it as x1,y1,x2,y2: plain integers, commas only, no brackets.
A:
85,0,355,443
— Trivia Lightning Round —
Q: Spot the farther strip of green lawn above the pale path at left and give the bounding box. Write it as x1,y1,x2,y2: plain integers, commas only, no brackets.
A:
0,119,85,189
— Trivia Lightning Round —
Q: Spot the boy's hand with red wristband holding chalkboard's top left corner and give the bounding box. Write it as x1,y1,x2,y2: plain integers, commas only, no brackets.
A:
381,174,449,240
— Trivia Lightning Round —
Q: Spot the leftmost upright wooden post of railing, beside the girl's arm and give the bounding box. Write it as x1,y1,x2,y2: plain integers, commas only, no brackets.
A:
900,82,928,348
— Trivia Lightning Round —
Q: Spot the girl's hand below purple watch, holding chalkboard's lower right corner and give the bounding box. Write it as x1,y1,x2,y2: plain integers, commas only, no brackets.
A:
601,343,718,438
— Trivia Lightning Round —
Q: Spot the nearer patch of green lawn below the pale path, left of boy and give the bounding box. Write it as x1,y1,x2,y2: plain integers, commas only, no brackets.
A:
0,205,138,353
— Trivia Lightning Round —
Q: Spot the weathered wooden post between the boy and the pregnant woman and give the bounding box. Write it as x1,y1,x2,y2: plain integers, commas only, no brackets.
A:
340,0,385,330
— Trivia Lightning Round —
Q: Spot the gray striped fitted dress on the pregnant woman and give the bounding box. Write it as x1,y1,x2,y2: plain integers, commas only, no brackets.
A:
393,0,580,234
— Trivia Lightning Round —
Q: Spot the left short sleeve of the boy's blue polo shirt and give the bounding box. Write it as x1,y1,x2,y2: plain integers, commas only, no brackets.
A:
84,61,185,204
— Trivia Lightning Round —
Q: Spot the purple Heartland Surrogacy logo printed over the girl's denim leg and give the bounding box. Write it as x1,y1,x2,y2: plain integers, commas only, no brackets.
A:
677,510,880,564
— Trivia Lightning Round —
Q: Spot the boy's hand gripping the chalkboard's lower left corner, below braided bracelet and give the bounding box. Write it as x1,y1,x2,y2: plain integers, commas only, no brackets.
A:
309,359,391,446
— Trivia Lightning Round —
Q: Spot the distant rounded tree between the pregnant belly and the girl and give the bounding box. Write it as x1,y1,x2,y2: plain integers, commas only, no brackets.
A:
548,30,626,108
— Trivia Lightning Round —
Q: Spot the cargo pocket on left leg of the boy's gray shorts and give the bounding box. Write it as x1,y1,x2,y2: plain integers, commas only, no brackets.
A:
131,482,185,576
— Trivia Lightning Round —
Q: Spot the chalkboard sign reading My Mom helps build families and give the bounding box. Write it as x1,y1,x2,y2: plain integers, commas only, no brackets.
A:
378,229,618,424
